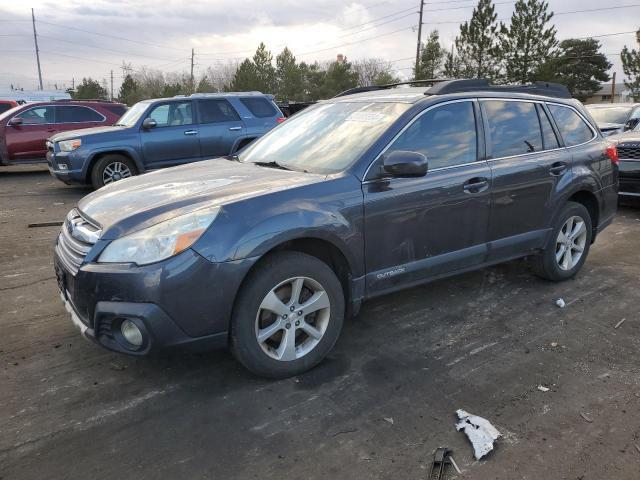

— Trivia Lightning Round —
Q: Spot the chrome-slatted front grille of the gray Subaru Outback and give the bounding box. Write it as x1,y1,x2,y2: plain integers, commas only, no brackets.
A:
56,209,101,275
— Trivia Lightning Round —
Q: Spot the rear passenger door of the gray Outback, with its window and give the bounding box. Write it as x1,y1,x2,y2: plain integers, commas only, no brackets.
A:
480,99,571,260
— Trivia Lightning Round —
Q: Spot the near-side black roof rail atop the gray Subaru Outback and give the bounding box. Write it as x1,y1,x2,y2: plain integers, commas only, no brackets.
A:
424,78,572,98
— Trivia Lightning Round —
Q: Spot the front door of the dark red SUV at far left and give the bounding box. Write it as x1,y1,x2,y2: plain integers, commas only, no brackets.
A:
5,105,56,161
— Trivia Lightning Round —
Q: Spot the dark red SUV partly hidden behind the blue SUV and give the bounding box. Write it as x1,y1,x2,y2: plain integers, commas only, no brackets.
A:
0,100,127,165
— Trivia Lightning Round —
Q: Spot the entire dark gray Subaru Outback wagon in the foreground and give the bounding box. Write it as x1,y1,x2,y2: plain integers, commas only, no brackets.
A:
55,80,618,377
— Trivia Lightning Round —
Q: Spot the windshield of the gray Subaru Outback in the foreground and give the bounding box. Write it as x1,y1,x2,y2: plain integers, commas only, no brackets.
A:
239,102,410,174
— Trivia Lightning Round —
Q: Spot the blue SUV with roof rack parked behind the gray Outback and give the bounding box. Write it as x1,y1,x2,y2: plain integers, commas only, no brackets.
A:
47,92,284,188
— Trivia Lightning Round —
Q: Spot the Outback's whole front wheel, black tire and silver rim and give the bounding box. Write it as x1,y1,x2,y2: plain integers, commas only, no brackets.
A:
230,252,345,378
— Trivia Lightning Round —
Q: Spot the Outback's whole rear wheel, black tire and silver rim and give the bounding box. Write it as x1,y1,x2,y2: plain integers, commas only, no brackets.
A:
532,202,593,282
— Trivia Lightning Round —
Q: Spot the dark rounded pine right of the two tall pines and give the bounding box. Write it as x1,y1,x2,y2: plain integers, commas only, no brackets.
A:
534,38,611,101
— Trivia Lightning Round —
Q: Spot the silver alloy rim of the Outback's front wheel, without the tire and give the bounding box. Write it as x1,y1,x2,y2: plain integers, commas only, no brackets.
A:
255,277,331,361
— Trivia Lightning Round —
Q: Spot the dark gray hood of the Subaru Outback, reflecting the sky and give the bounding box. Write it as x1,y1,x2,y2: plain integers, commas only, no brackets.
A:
78,158,326,240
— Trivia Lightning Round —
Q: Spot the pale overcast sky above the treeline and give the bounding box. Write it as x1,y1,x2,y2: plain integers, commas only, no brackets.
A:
0,0,640,89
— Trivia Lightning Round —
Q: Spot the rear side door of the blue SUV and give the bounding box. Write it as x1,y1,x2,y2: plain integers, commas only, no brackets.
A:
197,98,246,160
